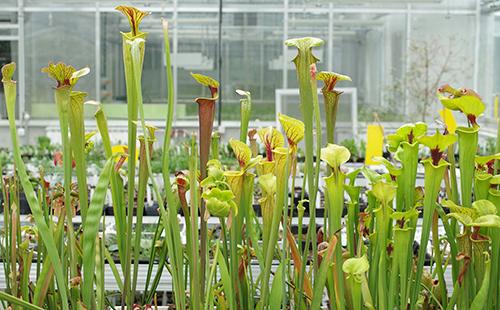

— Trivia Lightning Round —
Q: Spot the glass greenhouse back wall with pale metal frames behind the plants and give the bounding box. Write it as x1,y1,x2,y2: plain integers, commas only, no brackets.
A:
0,0,500,141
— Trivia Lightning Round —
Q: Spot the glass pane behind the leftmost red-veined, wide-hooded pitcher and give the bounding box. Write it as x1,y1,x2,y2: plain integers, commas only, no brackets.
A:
25,12,96,118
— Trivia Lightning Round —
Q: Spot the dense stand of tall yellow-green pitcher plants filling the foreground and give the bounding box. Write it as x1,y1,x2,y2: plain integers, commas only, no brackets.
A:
0,6,500,310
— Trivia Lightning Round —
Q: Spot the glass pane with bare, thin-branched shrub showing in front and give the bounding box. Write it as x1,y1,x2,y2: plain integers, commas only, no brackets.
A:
407,14,475,120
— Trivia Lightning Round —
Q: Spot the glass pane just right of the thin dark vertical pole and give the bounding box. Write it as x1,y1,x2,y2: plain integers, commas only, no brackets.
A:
222,13,283,121
